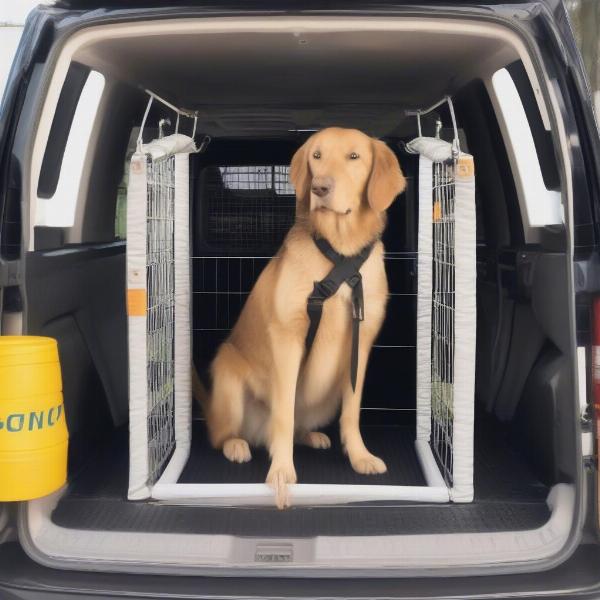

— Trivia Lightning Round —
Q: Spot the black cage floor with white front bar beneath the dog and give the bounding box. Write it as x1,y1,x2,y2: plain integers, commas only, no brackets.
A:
152,421,448,505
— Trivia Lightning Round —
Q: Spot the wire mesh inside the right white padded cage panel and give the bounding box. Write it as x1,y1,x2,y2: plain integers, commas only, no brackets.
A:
431,161,455,486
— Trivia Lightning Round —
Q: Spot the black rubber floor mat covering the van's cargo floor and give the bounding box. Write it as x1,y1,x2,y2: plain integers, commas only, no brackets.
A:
52,422,550,537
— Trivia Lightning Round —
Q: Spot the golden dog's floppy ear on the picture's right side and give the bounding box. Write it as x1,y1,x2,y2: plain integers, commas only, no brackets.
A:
367,140,406,212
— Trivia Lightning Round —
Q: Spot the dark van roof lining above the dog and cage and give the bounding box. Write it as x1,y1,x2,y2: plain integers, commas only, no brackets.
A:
74,31,518,133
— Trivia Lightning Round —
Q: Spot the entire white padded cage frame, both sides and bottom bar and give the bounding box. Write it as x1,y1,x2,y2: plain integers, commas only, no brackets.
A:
127,105,476,505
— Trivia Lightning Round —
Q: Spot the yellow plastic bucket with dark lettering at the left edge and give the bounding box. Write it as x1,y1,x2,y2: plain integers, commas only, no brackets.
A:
0,336,69,502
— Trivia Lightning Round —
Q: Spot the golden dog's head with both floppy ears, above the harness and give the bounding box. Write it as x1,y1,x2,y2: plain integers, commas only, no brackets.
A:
290,127,406,252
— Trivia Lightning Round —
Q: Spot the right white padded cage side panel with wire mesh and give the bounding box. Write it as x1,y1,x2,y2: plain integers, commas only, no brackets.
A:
408,137,476,502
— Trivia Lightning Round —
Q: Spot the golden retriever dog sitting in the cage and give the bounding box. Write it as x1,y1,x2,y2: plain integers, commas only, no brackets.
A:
193,128,405,508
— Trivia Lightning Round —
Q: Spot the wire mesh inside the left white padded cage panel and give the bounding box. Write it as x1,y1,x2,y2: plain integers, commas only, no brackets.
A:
146,155,175,483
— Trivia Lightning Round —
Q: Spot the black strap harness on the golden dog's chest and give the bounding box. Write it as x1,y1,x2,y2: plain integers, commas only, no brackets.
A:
306,238,373,391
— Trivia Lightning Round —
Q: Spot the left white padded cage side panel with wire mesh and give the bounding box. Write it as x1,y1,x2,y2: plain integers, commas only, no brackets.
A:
127,135,194,500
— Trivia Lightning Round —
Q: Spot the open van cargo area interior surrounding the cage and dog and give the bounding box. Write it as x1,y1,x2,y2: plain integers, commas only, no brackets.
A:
20,16,580,576
